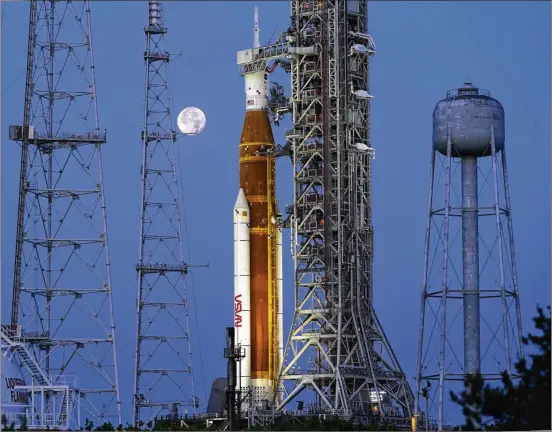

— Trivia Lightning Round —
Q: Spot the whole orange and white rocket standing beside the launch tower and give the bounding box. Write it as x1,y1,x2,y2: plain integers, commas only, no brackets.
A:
234,8,283,408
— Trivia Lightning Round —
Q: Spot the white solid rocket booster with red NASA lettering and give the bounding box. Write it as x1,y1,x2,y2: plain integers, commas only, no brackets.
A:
234,188,251,391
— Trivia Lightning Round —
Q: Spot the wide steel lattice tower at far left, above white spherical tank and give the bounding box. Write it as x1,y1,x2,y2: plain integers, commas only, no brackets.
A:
10,0,121,424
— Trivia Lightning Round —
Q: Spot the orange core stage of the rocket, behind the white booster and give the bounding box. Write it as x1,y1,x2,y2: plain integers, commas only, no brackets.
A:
239,110,280,390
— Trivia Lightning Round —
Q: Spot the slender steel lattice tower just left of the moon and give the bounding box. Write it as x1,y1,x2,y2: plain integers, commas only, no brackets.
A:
133,0,198,425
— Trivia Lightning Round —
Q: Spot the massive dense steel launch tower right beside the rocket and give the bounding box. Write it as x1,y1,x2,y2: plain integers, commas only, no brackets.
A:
281,0,413,419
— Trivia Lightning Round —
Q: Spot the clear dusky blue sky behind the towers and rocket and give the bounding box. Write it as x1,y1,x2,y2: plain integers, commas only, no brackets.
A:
1,1,551,421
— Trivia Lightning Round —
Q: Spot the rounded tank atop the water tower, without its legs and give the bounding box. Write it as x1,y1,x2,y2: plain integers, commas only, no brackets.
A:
433,83,504,157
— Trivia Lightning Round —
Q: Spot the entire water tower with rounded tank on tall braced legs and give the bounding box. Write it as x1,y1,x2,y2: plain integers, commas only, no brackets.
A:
416,83,523,429
